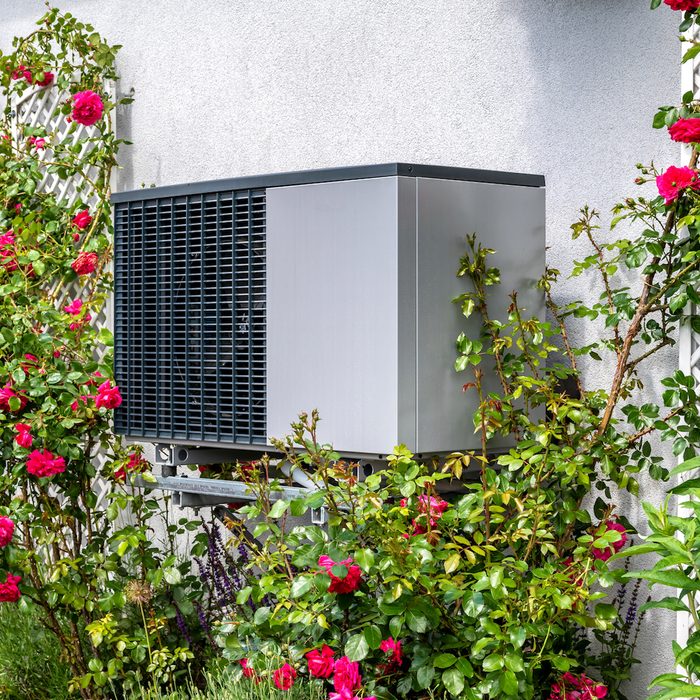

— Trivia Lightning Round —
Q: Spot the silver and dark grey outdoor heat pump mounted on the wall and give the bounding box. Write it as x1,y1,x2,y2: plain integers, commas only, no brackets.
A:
113,163,545,459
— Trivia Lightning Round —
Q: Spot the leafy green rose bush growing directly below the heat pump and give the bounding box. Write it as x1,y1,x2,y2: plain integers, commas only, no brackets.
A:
213,414,620,700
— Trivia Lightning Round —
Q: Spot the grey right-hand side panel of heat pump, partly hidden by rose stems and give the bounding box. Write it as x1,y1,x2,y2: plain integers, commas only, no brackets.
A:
417,178,545,453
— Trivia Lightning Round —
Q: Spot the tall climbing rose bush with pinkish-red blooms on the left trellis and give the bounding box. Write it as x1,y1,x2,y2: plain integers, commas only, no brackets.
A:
0,9,211,700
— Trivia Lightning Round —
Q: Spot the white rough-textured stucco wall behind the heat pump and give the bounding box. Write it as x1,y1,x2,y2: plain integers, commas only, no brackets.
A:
0,0,680,700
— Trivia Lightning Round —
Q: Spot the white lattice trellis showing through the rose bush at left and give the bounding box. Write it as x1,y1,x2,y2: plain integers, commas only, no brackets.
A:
12,84,115,502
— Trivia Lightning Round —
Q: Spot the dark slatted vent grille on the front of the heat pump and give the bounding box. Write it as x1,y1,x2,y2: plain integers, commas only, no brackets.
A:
114,190,266,444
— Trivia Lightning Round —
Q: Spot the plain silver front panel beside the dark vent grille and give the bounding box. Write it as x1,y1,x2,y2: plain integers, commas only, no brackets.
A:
267,177,399,455
